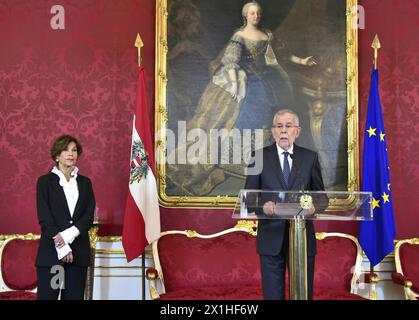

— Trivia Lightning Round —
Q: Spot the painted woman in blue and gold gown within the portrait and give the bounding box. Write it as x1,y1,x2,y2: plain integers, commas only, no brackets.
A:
167,2,316,196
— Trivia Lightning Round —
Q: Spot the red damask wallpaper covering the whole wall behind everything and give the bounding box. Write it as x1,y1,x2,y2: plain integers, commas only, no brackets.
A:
0,0,419,238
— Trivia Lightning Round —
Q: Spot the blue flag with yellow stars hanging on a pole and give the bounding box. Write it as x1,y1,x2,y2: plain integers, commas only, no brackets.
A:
359,69,396,266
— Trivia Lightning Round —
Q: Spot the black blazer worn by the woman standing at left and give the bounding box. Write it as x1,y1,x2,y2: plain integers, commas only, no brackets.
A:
36,172,96,267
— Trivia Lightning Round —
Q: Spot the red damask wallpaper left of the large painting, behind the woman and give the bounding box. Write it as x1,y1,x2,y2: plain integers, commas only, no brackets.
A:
0,0,155,234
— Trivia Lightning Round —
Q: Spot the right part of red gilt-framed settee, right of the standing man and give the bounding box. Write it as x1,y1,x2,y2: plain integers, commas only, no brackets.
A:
314,232,378,300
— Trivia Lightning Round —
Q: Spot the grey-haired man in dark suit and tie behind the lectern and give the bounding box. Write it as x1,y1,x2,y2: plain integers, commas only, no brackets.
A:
245,109,324,300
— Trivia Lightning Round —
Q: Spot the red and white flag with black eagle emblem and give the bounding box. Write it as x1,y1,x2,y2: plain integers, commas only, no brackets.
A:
122,66,160,262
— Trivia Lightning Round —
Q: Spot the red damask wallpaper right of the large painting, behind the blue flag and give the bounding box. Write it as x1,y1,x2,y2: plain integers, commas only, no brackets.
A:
359,0,419,239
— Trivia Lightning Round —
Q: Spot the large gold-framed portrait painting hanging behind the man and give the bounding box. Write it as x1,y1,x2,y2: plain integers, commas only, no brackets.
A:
155,0,358,208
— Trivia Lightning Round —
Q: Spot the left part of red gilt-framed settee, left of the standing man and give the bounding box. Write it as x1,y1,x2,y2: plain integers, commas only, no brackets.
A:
146,222,262,300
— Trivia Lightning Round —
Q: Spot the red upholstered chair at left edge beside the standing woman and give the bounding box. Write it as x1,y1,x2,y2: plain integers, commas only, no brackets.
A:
0,234,39,300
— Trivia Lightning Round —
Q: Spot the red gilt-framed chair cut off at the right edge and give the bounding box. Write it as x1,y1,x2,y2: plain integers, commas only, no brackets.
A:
392,238,419,300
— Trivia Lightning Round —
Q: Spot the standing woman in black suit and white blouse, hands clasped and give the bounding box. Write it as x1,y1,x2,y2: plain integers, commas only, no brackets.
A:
36,135,96,300
